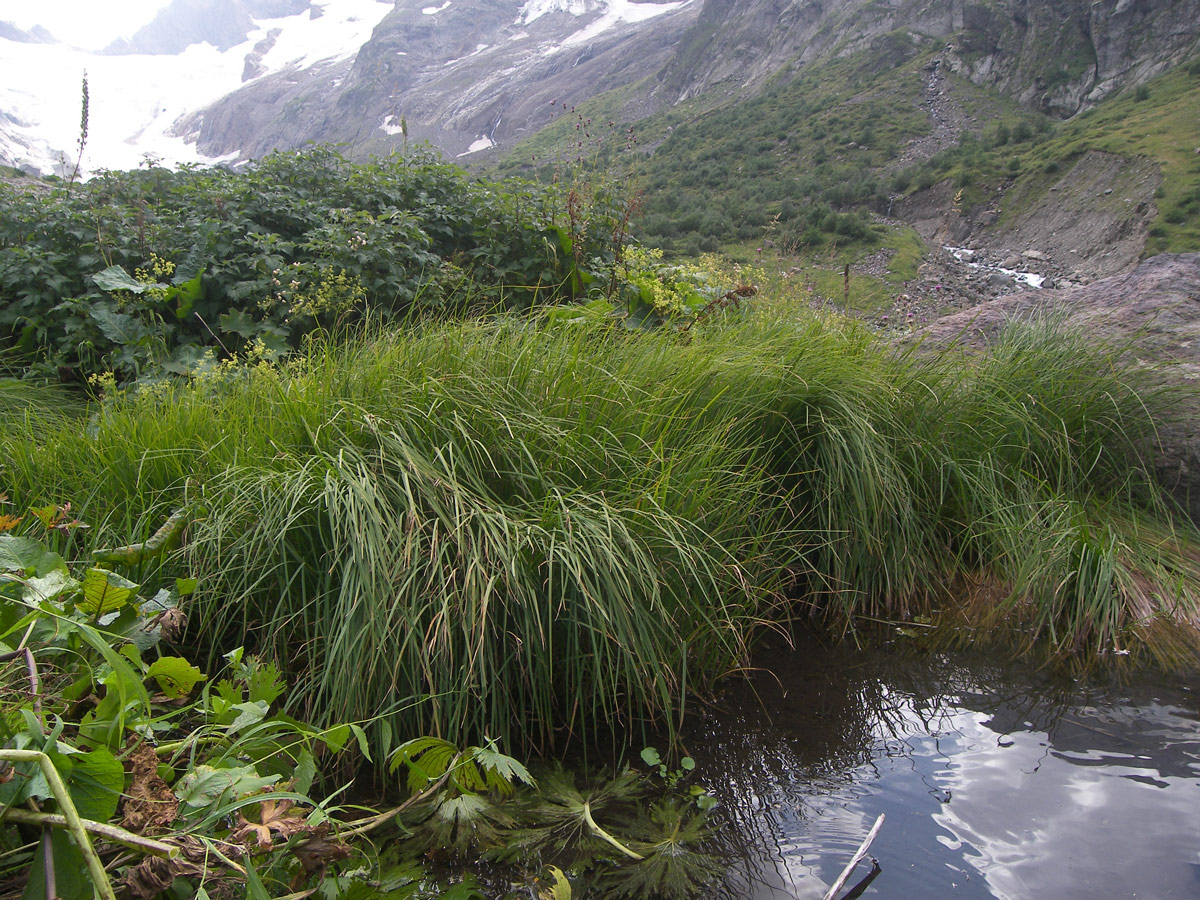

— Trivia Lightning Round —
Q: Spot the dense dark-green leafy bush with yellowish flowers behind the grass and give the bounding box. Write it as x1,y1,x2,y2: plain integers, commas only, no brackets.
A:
0,146,618,380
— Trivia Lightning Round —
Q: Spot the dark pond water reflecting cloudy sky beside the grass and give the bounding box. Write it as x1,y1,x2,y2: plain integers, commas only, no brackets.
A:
689,647,1200,900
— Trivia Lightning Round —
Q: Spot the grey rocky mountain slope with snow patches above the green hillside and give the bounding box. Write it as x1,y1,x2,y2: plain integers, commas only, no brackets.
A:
176,0,1200,164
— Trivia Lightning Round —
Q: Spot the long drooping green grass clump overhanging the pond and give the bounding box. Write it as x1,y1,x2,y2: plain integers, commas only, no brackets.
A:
0,313,1200,750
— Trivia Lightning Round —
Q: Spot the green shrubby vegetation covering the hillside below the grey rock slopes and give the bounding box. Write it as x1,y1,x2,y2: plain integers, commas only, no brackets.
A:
500,43,1200,289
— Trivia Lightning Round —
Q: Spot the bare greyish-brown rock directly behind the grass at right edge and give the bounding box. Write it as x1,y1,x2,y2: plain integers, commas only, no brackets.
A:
919,253,1200,522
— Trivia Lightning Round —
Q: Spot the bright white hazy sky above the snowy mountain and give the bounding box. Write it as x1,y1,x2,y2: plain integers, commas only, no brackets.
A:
0,0,169,50
